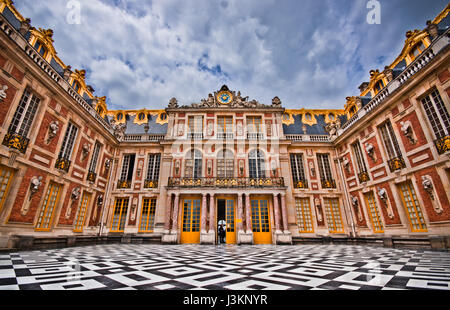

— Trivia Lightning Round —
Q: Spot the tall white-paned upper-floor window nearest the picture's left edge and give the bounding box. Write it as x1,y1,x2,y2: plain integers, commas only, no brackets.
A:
8,90,41,138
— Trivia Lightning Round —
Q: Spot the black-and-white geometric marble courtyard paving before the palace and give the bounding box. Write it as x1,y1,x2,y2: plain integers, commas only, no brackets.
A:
0,244,450,290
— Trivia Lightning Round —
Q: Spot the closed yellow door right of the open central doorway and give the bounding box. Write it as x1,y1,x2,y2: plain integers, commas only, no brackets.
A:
251,199,272,244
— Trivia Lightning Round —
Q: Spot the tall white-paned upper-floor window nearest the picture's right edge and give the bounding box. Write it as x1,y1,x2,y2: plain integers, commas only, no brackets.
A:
422,90,450,139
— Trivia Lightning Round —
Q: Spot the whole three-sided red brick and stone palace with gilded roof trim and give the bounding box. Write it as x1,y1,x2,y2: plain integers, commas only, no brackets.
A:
0,0,450,248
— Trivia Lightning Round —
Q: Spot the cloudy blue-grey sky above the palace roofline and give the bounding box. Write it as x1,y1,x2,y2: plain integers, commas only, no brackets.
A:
14,0,447,109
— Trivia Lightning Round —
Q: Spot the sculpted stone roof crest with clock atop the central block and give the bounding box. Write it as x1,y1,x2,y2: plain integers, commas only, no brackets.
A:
168,85,281,109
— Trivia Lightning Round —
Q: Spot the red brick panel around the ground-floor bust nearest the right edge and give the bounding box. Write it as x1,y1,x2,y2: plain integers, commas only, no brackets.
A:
414,167,450,222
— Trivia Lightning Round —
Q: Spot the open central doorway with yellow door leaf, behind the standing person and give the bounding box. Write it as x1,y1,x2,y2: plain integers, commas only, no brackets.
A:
216,198,236,244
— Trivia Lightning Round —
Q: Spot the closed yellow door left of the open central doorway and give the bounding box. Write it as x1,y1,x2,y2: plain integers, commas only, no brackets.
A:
181,199,201,243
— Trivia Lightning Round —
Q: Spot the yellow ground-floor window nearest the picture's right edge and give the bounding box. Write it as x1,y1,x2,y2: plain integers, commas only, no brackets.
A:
399,181,427,232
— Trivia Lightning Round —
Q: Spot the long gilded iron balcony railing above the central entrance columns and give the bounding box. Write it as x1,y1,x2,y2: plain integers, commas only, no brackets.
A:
167,178,284,188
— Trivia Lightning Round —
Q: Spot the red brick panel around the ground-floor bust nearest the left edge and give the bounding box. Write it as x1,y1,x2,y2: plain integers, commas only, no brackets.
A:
8,167,47,224
